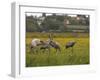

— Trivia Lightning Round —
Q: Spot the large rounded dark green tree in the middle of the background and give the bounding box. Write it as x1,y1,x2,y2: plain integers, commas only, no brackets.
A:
41,13,64,30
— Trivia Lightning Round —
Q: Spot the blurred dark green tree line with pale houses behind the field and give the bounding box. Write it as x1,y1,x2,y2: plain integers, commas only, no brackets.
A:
26,13,89,32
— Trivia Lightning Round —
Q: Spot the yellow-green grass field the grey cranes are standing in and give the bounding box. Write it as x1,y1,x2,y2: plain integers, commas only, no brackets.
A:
26,32,89,67
